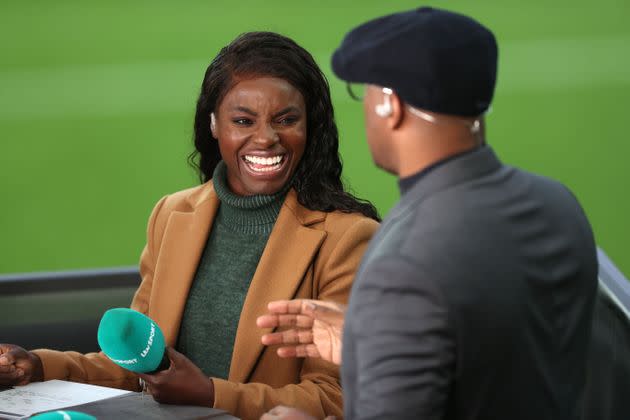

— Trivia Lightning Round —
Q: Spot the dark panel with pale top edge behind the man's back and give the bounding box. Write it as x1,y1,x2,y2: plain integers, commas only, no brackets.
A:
583,249,630,420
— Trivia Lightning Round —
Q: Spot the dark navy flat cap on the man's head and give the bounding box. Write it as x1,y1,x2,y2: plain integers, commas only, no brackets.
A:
332,7,497,116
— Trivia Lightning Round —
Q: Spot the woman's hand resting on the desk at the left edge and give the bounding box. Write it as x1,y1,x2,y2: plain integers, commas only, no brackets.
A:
0,344,44,386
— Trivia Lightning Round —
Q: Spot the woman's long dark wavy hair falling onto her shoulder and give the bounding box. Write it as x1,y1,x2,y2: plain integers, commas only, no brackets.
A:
189,32,379,220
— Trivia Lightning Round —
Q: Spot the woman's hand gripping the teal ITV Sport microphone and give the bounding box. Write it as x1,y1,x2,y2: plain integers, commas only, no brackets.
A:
138,347,214,407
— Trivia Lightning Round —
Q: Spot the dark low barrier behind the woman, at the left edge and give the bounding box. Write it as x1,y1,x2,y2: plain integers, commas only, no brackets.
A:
0,267,140,353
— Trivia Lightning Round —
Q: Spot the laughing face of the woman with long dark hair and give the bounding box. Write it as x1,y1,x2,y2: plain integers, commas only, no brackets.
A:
211,77,306,195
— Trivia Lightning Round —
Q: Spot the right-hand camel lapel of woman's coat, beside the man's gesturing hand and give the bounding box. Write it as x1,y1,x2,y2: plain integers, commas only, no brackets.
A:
229,190,326,382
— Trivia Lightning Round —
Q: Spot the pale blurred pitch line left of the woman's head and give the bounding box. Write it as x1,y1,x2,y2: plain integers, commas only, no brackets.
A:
0,60,208,120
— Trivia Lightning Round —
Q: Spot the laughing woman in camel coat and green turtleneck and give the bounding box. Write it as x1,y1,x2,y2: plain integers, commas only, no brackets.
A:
0,32,377,419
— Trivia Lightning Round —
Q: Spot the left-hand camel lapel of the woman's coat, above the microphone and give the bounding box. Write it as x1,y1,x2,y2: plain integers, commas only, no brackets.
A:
149,182,219,346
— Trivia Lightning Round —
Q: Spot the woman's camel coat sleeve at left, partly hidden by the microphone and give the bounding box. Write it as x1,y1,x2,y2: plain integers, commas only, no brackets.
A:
33,197,166,390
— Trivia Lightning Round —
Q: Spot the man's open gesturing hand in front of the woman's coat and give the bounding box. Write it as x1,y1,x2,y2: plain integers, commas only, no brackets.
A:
256,299,346,365
